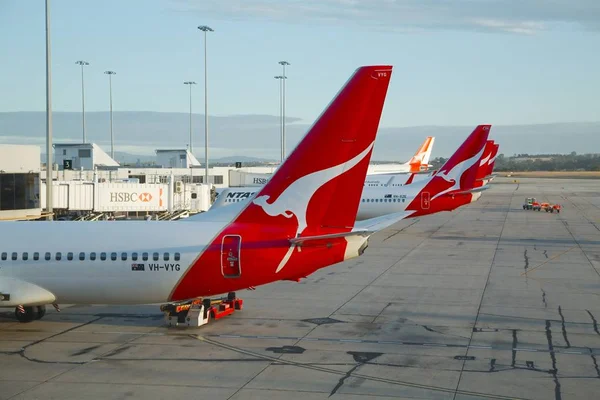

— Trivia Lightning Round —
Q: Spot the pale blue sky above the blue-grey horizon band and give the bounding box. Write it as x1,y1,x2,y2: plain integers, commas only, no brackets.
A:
0,0,600,127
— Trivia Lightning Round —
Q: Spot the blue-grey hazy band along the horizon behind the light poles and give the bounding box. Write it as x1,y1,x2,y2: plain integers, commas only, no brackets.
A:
0,111,600,162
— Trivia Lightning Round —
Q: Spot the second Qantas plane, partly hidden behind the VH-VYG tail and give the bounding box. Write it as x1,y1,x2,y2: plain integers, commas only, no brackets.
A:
211,125,491,221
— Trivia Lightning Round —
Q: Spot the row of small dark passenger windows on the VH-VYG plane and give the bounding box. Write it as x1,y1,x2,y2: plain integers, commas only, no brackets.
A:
0,251,181,261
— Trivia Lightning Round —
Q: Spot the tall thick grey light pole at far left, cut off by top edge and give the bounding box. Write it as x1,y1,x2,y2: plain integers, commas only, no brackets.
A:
46,0,54,221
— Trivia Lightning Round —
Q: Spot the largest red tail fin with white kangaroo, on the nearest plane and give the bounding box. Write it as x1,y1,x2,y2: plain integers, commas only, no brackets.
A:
237,66,392,237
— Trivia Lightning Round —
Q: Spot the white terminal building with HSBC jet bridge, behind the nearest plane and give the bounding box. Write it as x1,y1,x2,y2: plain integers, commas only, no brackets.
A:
0,143,277,220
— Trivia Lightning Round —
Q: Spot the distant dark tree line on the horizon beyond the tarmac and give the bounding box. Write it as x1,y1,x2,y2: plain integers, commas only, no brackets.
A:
431,152,600,172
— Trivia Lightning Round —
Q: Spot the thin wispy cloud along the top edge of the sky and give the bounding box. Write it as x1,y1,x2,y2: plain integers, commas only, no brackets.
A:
167,0,600,35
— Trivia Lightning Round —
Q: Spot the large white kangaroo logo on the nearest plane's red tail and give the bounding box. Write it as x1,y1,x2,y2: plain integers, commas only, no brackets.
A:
252,142,374,272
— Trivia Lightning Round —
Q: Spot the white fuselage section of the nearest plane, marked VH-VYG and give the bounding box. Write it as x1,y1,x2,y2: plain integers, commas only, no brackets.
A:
0,221,224,306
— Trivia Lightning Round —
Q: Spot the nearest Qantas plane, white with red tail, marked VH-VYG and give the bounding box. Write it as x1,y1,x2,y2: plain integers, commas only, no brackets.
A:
0,65,399,322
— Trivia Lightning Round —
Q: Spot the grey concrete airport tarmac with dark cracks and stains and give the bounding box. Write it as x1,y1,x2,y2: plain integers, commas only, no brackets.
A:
0,178,600,400
